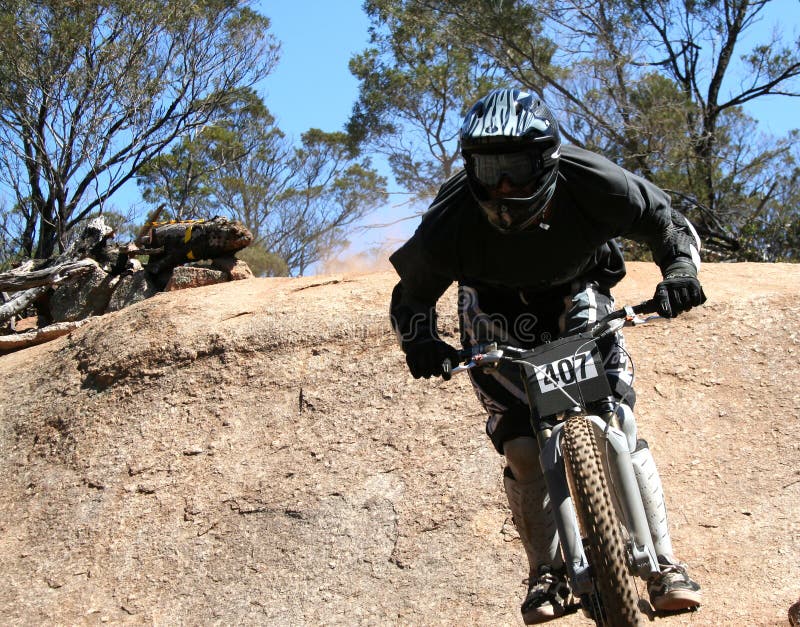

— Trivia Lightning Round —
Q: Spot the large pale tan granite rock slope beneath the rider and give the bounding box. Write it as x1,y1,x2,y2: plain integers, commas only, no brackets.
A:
0,263,800,626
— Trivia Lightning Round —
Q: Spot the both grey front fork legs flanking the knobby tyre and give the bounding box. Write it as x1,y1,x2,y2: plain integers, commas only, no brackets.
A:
537,416,659,595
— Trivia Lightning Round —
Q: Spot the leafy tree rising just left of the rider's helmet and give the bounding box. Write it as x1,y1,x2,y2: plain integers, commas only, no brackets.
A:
348,0,510,199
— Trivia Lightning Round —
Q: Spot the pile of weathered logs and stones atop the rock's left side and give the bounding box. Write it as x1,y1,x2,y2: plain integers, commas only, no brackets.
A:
0,213,253,344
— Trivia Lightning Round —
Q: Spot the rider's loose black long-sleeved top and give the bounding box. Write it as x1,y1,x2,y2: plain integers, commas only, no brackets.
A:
390,145,700,330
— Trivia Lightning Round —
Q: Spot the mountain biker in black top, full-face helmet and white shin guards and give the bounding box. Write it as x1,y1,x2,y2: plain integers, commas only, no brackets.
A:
390,89,705,624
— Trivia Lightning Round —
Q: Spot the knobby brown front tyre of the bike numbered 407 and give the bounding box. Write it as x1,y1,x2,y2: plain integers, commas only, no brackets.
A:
561,416,642,627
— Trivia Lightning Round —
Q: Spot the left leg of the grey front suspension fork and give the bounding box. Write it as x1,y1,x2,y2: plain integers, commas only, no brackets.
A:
537,423,592,595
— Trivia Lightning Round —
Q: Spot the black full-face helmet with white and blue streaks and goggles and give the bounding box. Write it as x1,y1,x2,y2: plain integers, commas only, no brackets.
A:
460,89,561,232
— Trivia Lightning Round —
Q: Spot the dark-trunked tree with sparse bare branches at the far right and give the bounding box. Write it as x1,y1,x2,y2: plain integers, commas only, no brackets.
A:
544,0,800,258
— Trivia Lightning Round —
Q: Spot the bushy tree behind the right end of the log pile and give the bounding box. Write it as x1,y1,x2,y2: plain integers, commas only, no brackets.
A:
138,89,386,274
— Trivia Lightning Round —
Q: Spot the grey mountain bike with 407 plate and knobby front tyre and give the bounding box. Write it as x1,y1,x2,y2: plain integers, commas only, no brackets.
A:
450,300,660,627
